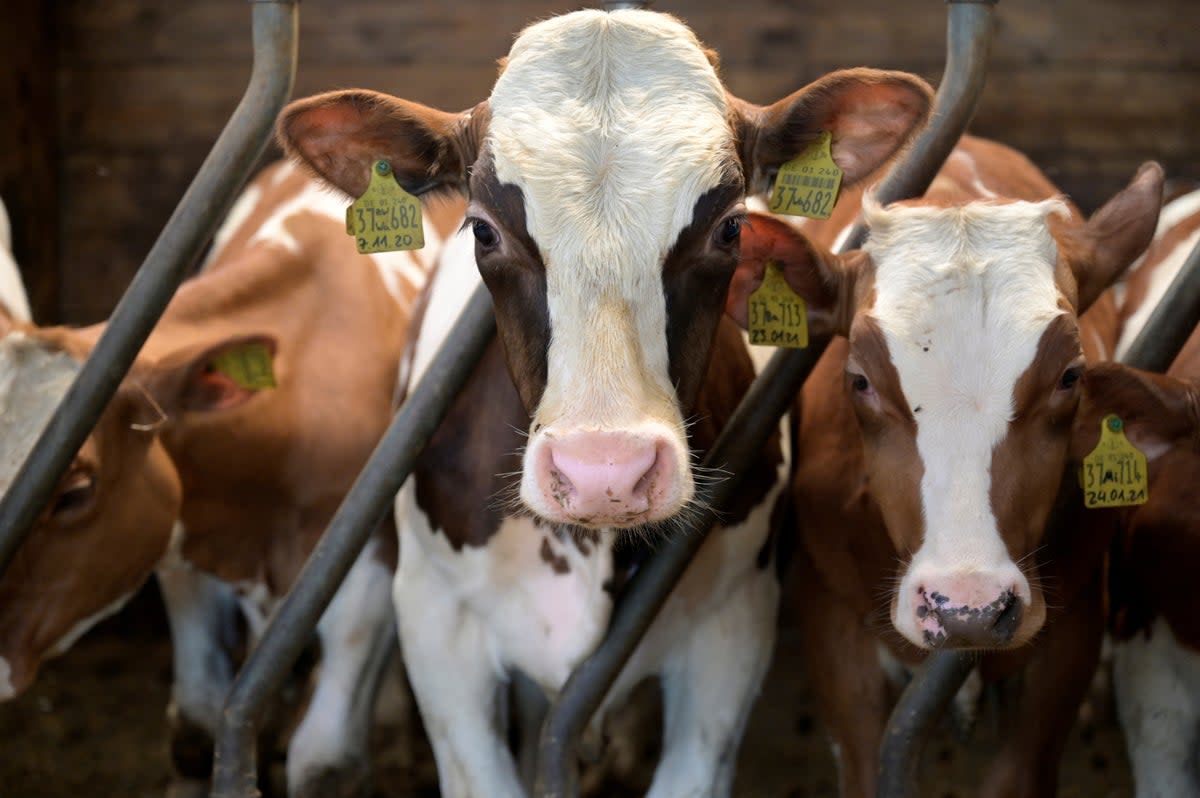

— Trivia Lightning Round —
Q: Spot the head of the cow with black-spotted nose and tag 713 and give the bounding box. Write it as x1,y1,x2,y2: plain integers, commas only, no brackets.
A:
730,164,1163,648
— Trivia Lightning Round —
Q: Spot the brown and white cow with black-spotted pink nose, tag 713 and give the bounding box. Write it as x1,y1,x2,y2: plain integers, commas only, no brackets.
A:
731,137,1163,796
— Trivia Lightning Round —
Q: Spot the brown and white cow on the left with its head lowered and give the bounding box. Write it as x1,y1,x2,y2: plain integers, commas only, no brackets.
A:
0,163,462,796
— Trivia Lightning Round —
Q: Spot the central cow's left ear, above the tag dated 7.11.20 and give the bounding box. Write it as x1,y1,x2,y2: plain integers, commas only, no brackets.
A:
276,89,488,197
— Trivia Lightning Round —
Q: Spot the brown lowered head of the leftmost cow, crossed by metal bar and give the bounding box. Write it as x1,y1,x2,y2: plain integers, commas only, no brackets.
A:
0,328,180,700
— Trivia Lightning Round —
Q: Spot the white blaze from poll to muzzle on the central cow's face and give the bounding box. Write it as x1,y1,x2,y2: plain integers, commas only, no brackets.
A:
488,11,734,424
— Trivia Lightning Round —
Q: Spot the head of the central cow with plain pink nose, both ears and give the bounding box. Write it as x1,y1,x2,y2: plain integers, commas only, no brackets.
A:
278,11,930,527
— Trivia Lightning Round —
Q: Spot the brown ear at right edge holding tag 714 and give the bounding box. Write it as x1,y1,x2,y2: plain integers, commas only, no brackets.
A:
1072,362,1200,461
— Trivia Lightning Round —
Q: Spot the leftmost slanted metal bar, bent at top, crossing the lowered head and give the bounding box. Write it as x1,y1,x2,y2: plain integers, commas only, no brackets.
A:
0,0,299,574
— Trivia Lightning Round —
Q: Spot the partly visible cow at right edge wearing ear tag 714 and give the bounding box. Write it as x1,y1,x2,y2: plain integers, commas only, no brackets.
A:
1074,184,1200,798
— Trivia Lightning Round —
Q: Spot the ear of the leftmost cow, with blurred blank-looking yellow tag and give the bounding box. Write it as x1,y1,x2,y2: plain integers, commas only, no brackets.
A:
145,335,278,418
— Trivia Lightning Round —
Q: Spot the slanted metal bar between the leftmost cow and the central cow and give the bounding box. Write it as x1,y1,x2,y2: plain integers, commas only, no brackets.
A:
211,287,496,798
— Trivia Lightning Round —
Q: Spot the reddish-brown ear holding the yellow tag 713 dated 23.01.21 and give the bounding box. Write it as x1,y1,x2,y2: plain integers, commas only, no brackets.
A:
725,214,866,336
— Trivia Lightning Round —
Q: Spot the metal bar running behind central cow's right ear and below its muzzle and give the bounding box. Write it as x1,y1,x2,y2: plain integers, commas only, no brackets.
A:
535,0,995,798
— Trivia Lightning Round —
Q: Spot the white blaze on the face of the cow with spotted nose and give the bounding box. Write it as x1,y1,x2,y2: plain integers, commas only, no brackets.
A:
865,200,1067,573
